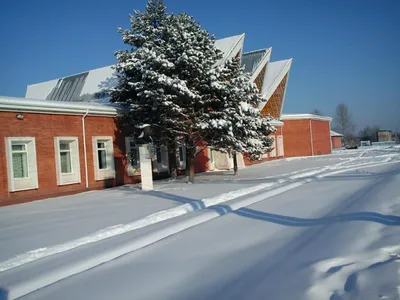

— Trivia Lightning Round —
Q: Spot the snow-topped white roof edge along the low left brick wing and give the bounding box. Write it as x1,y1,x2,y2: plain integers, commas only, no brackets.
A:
0,96,119,117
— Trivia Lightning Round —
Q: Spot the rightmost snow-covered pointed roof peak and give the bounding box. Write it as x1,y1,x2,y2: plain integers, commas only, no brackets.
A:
259,58,292,109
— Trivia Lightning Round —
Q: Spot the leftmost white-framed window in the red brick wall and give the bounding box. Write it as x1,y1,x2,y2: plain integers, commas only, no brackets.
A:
5,137,39,192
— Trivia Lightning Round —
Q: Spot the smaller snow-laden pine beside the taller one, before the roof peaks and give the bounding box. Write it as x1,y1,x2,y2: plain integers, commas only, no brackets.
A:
205,58,275,175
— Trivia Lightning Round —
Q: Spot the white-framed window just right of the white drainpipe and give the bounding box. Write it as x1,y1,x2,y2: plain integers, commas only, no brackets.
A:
93,136,115,180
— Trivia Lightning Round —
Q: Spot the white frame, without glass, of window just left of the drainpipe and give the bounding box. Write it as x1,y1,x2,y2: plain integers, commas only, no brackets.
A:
54,136,81,185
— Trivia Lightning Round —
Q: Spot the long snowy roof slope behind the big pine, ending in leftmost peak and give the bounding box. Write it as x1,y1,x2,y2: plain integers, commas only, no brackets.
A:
25,33,245,104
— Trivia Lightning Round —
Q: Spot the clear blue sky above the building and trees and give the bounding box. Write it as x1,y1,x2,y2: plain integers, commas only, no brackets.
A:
0,0,400,130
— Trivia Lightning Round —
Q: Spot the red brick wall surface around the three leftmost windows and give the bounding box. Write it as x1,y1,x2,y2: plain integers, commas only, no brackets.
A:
0,112,138,206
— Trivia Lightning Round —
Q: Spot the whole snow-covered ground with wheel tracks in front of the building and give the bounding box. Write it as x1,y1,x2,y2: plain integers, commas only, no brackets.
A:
0,149,400,299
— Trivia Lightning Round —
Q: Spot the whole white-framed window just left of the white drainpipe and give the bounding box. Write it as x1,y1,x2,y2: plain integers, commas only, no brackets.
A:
54,136,81,185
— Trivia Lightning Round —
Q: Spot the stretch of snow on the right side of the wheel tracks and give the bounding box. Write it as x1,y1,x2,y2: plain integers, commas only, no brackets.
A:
14,157,400,300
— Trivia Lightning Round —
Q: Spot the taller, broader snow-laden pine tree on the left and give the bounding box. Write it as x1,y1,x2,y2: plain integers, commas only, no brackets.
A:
110,0,222,182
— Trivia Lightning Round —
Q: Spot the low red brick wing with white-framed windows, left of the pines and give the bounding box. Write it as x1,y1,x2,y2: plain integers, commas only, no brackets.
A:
0,97,186,206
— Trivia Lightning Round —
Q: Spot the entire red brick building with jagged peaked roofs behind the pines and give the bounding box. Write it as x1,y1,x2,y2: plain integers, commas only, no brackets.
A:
0,34,331,205
